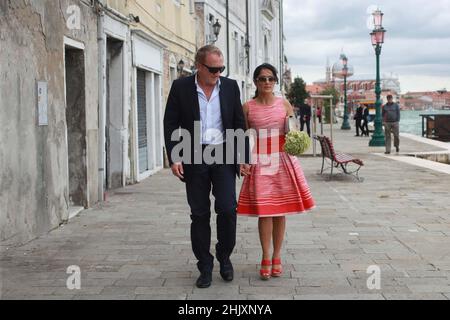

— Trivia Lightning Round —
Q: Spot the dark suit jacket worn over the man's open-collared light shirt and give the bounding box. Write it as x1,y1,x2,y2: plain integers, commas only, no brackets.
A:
164,76,249,179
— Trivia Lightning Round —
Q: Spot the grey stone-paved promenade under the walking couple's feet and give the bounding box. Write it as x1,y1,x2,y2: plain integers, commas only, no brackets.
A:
0,130,450,300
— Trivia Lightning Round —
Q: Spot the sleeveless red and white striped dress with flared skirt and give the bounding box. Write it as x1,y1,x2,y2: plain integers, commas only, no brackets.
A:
237,98,315,217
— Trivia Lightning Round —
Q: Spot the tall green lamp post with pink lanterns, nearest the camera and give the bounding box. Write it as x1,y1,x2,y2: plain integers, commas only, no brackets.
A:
369,9,386,147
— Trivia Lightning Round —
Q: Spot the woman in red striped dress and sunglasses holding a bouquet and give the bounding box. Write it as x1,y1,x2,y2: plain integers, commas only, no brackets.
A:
237,64,314,280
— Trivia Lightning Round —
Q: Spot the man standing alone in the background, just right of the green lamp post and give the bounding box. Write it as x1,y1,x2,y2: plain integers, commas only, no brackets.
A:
382,94,400,154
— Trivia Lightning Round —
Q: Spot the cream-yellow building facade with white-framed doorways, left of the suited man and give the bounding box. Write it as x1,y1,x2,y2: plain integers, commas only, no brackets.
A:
99,0,196,200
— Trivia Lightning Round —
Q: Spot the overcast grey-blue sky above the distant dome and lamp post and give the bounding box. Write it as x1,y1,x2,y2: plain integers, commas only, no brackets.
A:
284,0,450,93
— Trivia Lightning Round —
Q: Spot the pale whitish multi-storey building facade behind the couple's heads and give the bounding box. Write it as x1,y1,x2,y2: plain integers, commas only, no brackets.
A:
195,0,285,101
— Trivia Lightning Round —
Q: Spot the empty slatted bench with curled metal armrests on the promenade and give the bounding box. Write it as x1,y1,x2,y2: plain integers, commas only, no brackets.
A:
314,135,364,182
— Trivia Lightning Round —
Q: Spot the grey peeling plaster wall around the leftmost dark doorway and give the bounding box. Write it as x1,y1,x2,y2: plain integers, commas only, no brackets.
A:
0,0,98,245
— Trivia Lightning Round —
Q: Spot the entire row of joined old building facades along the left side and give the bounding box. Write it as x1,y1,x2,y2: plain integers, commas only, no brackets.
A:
0,0,288,244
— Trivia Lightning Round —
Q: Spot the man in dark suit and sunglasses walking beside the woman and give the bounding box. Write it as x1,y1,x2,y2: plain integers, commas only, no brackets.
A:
164,45,249,288
